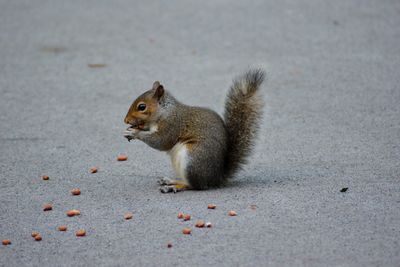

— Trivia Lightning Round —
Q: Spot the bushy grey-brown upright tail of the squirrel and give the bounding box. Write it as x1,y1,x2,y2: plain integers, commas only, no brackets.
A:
224,69,265,178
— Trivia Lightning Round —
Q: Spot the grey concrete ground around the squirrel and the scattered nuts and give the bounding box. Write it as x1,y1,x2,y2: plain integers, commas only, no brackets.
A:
0,0,400,266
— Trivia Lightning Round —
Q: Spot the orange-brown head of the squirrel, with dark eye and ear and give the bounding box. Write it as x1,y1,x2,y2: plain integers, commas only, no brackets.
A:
124,81,164,128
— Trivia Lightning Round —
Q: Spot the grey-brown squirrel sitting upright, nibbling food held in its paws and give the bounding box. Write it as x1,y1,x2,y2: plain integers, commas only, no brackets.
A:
124,69,265,193
